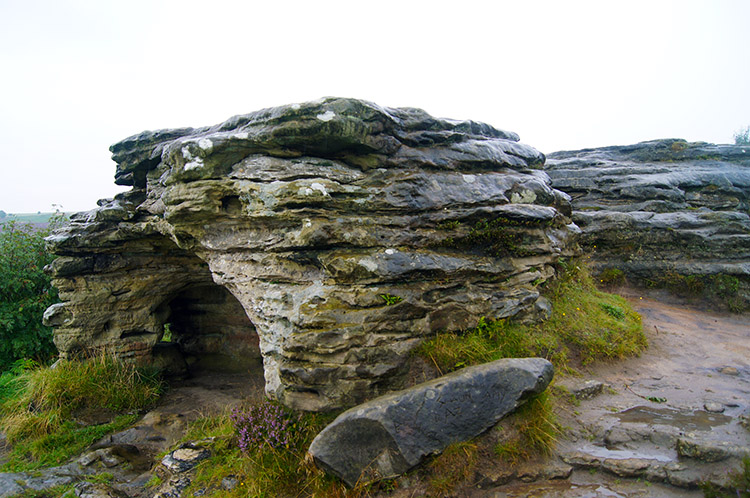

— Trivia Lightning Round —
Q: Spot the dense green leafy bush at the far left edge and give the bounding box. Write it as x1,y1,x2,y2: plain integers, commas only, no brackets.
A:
0,219,62,371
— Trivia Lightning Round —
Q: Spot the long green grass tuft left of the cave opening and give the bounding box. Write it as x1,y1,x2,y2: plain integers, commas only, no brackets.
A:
0,355,161,472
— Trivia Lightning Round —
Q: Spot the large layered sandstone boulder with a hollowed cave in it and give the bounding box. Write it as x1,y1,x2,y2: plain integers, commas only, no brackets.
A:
46,98,577,410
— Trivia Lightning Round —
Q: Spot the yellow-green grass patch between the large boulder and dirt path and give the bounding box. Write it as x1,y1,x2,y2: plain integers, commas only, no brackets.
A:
418,261,647,373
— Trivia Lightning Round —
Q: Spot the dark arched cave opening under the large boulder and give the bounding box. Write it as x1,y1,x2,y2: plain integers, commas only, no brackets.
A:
153,282,262,377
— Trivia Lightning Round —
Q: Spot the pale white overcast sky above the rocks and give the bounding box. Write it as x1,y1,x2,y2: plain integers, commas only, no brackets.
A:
0,0,750,212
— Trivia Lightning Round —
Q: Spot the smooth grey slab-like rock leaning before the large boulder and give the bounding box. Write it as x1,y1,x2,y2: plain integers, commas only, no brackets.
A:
309,358,554,486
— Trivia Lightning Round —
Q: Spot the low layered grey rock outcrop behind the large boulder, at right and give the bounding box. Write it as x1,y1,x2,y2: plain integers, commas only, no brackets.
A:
545,139,750,307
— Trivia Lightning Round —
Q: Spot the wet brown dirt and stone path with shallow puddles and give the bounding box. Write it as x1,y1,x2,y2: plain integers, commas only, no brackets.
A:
494,289,750,498
